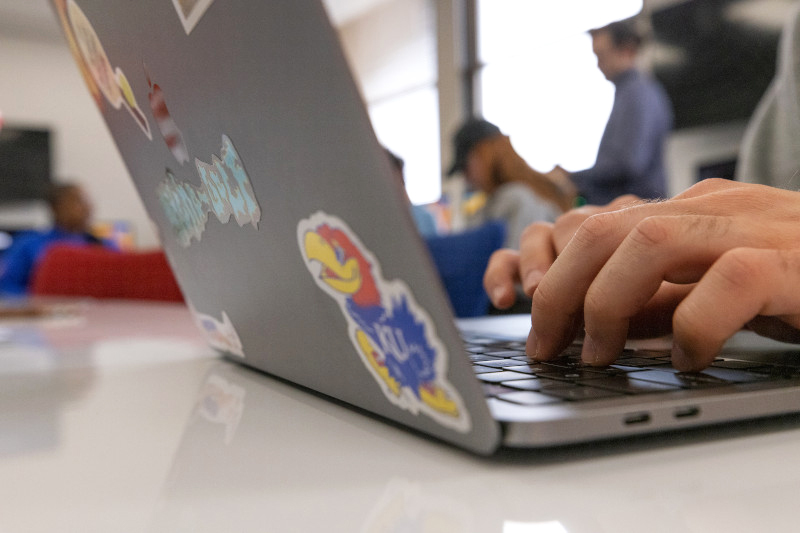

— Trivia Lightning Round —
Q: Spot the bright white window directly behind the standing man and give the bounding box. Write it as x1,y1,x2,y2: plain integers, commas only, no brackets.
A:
476,0,642,171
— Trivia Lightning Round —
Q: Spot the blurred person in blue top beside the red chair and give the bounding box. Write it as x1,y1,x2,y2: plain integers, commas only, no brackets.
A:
0,183,114,296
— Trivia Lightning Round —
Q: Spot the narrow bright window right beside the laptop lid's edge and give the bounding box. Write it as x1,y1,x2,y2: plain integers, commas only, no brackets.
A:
339,0,441,204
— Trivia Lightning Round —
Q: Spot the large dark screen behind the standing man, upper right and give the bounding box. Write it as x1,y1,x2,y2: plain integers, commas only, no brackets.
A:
651,0,780,129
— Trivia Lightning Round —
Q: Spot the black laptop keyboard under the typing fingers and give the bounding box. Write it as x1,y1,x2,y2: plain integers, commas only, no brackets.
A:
464,337,800,405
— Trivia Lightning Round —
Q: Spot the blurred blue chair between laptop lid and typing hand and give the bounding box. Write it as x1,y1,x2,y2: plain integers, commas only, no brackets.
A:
425,222,506,318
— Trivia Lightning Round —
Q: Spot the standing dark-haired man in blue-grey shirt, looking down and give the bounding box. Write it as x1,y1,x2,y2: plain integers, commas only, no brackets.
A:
548,20,673,205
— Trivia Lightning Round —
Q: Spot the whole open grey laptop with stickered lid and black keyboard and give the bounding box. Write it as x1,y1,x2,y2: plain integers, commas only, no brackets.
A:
54,0,800,454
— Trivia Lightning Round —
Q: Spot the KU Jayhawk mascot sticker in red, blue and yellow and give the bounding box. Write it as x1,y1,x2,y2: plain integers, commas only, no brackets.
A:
297,212,471,432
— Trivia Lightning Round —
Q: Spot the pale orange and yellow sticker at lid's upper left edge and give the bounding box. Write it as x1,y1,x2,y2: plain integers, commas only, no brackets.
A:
65,0,153,140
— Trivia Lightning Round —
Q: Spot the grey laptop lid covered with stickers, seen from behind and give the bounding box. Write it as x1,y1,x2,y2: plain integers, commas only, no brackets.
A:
54,0,500,452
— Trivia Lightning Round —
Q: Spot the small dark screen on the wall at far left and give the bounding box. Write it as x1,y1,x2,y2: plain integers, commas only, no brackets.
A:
0,126,51,204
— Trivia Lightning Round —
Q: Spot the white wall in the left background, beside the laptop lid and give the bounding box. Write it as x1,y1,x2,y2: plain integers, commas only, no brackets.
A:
0,35,158,248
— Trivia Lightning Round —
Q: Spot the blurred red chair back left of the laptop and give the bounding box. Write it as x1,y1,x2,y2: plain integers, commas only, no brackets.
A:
31,245,184,302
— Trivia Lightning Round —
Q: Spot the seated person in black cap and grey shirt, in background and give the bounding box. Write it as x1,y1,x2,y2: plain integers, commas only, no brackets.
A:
448,118,575,248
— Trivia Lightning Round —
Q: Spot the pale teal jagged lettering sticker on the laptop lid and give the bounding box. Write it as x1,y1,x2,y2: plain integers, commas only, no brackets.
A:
156,135,261,248
